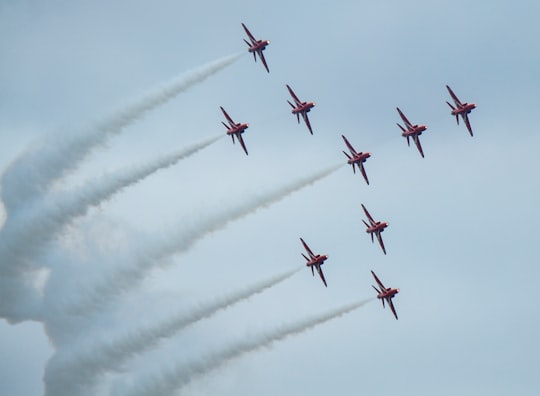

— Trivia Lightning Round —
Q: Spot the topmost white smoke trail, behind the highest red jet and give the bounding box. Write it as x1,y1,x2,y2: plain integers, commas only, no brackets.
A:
1,52,240,215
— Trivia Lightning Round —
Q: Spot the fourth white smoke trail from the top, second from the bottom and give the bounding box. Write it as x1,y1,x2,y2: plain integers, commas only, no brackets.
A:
45,267,303,396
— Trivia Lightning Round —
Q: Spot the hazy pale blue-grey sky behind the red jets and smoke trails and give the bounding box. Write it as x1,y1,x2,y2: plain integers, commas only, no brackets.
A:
0,0,540,396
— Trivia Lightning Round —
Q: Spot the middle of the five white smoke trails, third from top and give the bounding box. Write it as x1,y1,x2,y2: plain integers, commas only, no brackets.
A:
68,164,343,315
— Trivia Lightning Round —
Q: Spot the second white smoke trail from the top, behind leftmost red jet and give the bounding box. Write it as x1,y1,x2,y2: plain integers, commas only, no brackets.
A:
0,135,220,318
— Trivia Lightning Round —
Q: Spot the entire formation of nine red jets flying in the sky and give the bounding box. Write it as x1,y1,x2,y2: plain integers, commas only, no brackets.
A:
221,23,476,319
